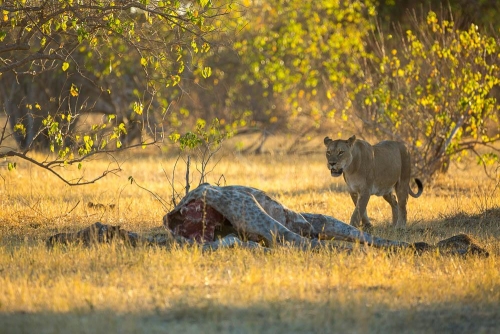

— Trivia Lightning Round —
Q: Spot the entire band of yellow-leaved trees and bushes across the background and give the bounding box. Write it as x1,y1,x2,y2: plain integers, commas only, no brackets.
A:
0,0,500,184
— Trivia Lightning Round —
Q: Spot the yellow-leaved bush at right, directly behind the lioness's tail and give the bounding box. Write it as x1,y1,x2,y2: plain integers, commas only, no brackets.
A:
353,12,500,177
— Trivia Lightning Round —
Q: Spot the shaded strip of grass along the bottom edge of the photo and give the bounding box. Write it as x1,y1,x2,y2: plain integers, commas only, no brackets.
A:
0,298,500,334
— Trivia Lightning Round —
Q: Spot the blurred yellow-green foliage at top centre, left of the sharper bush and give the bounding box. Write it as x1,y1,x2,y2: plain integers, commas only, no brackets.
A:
230,0,375,140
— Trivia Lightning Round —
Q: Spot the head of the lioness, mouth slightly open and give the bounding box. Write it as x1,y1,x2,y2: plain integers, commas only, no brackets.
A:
324,136,356,177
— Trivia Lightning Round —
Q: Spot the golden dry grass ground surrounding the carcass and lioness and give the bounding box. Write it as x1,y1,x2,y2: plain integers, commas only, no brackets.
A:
0,142,500,333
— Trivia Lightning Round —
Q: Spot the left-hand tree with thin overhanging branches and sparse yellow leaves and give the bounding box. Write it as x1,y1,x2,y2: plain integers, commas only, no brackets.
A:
0,0,231,183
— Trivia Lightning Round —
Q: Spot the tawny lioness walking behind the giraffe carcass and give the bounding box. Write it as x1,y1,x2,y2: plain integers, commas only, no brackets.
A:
324,136,424,228
